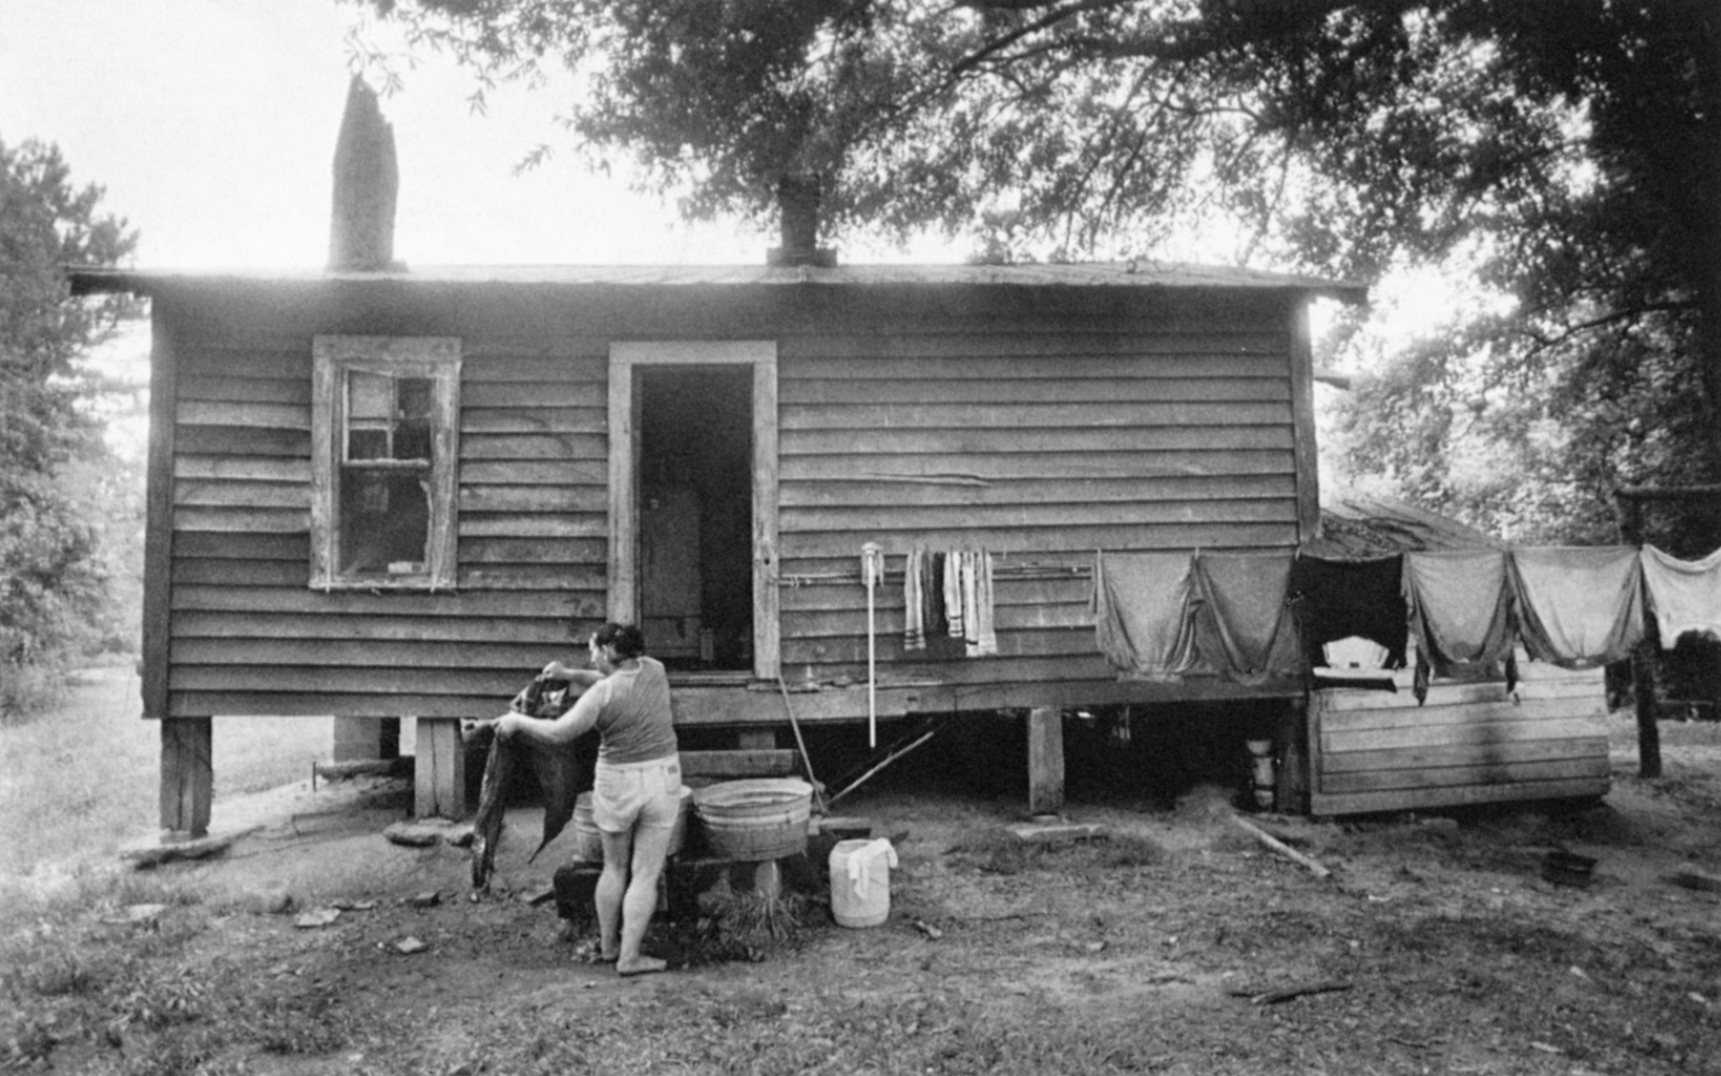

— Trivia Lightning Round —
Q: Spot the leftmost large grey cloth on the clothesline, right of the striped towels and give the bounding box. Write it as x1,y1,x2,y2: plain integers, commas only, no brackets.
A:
1093,553,1203,680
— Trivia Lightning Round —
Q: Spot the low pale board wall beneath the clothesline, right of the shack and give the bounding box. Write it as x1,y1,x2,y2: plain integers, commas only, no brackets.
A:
1310,663,1609,814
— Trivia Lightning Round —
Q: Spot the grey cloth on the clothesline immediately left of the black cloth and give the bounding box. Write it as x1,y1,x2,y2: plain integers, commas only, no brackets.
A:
1194,551,1303,683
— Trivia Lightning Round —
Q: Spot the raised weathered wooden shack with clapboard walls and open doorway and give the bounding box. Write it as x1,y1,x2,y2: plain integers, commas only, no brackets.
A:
71,263,1363,830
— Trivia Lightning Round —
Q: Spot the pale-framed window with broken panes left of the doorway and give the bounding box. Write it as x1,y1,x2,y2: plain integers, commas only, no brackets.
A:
312,336,460,589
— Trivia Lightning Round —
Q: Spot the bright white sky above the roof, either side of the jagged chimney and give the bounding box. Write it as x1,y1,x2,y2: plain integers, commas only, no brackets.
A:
0,0,867,269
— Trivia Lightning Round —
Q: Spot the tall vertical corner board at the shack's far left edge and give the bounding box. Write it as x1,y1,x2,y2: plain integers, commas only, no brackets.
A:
139,301,181,723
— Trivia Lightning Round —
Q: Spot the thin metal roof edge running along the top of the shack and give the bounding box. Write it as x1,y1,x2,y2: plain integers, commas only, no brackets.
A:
65,262,1368,301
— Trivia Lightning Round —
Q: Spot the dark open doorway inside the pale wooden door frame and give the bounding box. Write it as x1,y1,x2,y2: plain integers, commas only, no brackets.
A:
635,365,754,670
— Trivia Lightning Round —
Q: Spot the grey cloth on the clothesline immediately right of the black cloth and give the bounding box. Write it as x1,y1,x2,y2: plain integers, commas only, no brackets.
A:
1404,549,1518,702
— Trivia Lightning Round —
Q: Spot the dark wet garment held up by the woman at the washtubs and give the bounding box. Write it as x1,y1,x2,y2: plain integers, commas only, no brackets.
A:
472,689,597,888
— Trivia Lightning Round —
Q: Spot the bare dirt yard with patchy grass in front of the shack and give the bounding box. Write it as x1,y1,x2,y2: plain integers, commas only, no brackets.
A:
0,716,1721,1076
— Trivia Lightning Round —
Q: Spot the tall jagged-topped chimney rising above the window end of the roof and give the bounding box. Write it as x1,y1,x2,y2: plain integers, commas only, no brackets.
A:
329,76,401,272
